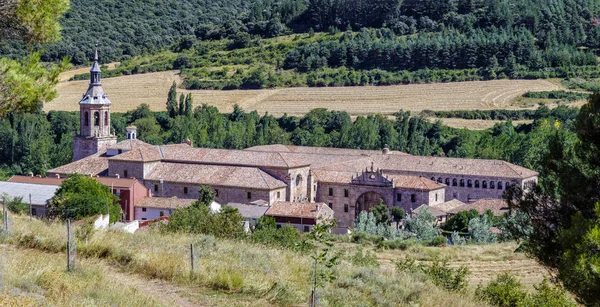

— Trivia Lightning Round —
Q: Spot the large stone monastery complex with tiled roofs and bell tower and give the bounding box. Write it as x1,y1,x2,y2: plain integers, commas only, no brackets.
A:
48,45,538,227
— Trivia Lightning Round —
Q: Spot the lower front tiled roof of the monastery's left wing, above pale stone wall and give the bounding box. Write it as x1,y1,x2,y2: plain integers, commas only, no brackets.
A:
145,162,287,190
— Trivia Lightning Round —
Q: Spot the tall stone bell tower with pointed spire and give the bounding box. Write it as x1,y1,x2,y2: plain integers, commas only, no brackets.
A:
73,42,117,161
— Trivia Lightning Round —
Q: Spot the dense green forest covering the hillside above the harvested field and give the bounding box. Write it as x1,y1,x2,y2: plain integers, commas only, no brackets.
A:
0,0,600,89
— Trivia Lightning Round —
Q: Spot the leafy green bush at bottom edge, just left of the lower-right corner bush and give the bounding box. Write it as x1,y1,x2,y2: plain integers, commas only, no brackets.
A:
475,273,527,307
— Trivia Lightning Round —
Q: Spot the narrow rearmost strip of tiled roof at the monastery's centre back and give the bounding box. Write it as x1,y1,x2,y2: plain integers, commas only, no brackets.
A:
246,144,408,156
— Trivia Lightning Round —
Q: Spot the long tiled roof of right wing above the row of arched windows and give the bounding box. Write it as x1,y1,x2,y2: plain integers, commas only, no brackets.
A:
373,155,538,179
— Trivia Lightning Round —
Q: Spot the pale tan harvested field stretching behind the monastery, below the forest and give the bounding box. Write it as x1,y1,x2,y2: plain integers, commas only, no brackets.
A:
45,71,560,115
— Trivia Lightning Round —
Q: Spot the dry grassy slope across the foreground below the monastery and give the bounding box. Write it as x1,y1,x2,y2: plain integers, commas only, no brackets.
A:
0,216,546,306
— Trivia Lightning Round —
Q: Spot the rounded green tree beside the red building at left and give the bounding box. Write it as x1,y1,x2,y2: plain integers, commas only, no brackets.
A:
48,175,121,223
